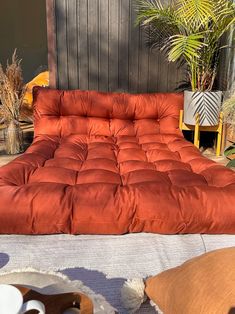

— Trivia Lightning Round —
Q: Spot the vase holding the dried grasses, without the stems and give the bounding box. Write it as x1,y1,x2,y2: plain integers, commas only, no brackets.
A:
4,120,23,155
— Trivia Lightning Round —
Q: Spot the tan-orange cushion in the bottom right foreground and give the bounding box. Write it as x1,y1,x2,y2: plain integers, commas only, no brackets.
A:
146,247,235,314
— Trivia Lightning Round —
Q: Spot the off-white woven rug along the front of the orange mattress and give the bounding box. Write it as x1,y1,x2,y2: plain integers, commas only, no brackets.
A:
0,233,235,314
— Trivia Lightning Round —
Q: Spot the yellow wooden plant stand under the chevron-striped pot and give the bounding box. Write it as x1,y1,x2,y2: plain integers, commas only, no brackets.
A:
179,110,223,156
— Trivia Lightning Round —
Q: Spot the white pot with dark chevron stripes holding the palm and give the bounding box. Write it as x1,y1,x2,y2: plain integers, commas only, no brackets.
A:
184,91,222,126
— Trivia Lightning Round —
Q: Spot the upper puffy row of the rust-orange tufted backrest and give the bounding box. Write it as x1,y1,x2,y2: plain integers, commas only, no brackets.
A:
35,88,183,134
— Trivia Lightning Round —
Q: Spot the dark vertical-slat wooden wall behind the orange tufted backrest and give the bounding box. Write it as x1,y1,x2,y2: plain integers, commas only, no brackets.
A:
47,0,185,92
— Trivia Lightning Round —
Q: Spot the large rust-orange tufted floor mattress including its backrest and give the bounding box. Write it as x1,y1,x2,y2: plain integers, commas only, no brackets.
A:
0,87,235,234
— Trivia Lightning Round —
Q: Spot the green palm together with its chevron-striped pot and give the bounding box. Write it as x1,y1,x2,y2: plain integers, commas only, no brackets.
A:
137,0,235,126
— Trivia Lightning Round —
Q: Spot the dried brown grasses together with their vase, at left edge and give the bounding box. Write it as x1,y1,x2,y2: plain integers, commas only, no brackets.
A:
0,50,24,154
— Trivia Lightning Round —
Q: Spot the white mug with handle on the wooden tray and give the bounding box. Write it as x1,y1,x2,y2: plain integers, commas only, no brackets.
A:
0,284,46,314
